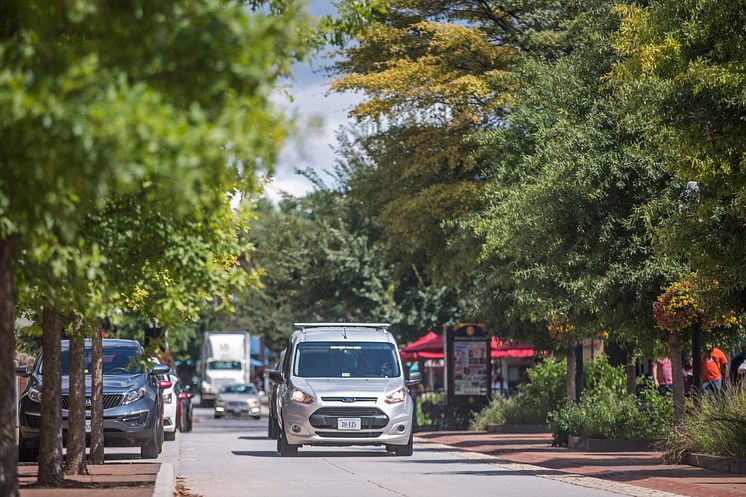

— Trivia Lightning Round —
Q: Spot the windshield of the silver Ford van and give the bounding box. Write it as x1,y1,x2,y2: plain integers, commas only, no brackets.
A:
293,342,401,378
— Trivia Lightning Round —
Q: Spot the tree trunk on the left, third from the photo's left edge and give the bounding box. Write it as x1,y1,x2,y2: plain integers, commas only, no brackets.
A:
65,317,88,475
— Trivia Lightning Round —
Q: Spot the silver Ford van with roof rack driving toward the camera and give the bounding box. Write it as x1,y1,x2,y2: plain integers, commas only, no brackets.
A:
269,323,422,456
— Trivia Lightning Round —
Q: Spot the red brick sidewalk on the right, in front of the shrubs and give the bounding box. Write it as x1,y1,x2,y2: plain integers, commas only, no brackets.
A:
417,431,746,497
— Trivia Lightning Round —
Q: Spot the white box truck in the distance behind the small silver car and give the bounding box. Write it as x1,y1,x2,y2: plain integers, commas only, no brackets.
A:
199,331,251,406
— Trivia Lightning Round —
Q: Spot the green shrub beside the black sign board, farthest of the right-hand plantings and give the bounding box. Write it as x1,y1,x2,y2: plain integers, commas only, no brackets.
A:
471,360,566,430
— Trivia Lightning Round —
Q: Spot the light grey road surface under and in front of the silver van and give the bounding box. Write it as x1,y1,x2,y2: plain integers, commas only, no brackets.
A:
107,409,632,497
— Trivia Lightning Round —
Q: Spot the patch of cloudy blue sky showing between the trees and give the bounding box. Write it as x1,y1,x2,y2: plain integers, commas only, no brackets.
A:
266,0,360,201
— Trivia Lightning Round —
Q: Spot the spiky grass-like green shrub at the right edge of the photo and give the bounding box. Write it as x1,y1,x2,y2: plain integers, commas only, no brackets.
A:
661,388,746,463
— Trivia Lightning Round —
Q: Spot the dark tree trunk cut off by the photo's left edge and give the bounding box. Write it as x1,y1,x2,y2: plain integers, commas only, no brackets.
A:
0,236,18,497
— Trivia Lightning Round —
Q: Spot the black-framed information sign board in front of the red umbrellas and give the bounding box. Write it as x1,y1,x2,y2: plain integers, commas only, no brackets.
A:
444,323,492,427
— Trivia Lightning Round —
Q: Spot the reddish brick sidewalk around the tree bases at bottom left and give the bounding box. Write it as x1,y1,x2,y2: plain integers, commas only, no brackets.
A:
18,463,161,497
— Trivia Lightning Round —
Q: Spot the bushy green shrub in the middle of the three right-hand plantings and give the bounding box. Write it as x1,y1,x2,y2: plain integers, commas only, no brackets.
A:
547,358,673,445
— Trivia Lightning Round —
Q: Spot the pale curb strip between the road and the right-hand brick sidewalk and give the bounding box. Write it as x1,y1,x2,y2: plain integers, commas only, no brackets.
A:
414,437,682,497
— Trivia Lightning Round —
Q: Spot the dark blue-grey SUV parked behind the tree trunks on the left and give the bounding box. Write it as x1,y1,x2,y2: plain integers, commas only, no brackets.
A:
18,339,168,462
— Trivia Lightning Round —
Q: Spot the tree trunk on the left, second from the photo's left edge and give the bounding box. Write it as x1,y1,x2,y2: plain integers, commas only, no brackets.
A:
39,306,65,486
